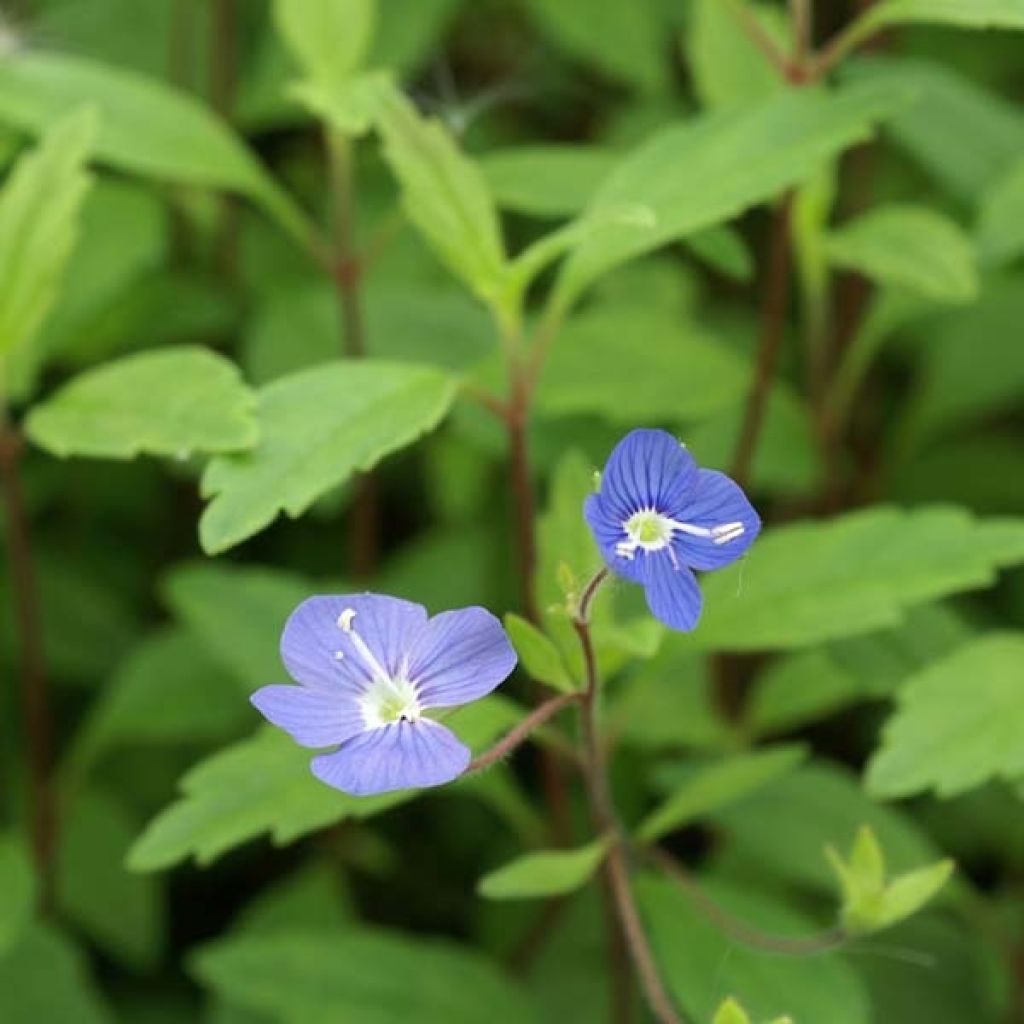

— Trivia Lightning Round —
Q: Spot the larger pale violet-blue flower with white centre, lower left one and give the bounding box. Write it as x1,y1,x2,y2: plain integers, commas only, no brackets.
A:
251,594,516,796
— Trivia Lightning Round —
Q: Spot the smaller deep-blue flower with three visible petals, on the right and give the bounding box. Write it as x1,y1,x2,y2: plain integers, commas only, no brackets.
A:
584,430,761,630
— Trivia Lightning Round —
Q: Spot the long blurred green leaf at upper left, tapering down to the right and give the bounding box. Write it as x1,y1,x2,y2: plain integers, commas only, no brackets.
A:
0,49,311,244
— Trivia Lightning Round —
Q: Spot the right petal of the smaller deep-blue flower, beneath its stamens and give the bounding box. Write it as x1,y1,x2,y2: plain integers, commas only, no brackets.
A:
673,469,761,569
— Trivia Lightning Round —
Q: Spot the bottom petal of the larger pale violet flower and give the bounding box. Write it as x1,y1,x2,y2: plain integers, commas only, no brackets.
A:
312,718,470,797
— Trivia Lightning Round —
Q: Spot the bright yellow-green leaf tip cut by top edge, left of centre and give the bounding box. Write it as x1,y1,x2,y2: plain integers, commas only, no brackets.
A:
273,0,377,90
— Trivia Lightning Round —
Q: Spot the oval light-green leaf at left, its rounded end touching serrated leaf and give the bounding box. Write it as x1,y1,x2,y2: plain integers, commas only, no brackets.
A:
26,346,259,459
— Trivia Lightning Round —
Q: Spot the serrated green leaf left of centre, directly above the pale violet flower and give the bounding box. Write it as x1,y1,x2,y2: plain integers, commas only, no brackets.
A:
200,359,456,554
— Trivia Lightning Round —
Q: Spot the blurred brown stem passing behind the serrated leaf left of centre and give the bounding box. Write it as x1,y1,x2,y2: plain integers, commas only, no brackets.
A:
327,129,379,580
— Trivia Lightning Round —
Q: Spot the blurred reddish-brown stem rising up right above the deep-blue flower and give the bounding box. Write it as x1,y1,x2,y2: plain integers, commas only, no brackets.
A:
732,193,793,485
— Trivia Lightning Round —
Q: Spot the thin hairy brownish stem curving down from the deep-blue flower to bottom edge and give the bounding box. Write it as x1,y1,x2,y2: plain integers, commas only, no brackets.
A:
572,569,682,1024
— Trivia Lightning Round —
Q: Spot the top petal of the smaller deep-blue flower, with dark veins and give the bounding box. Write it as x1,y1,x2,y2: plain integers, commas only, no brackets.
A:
601,430,697,522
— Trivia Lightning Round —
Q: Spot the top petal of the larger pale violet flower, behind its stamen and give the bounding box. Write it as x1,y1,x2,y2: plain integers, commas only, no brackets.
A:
281,594,427,689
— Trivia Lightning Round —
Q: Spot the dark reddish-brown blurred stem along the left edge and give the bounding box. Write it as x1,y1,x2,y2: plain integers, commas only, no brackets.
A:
0,415,57,911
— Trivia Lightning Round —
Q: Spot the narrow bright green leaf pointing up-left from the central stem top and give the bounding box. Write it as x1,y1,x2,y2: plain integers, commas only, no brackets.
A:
375,82,505,302
